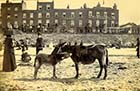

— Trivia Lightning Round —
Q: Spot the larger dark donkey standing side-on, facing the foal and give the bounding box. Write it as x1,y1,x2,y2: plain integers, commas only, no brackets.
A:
61,45,109,79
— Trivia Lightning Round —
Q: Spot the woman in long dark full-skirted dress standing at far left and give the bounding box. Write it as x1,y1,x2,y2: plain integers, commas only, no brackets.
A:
3,34,17,72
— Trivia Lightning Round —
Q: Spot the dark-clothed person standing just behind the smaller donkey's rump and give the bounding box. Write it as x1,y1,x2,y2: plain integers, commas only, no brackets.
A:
36,33,43,55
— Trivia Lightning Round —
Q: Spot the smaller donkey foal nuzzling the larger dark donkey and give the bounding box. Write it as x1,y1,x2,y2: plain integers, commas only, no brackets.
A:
34,42,70,79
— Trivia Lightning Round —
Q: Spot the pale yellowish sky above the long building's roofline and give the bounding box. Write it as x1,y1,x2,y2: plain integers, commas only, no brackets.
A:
0,0,140,25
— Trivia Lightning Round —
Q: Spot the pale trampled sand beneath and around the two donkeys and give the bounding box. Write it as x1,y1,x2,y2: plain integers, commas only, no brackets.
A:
0,48,140,91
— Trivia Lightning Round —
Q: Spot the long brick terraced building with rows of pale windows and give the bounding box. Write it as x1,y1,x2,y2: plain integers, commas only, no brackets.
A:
1,0,119,32
